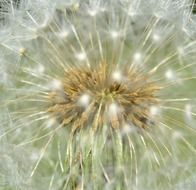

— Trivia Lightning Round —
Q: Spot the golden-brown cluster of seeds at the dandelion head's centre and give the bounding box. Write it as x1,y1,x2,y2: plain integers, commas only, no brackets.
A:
48,62,159,129
